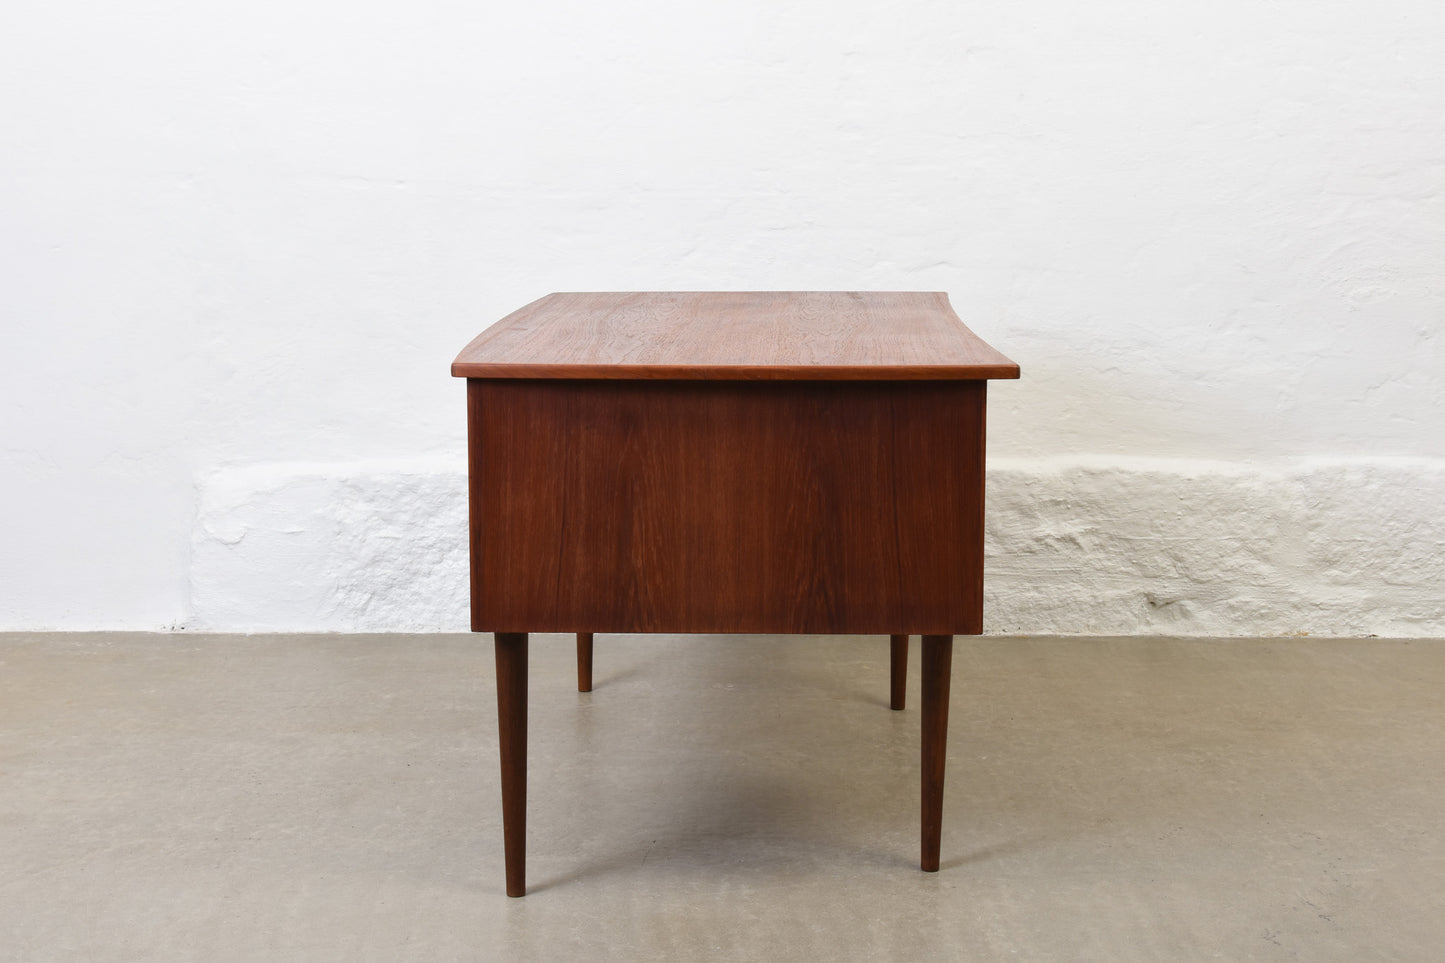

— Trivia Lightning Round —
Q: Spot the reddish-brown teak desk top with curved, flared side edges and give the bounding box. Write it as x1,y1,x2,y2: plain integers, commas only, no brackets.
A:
452,291,1019,380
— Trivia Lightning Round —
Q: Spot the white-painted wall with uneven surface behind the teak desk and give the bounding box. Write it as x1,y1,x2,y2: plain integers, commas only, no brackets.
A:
0,0,1445,635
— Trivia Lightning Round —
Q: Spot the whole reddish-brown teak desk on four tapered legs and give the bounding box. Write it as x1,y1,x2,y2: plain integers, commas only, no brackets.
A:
452,292,1019,896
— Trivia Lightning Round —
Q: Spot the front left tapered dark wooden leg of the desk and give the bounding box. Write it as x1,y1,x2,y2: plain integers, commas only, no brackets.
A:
496,632,527,896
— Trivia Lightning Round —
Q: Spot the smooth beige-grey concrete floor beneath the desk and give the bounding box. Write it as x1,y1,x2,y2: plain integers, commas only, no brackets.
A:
0,635,1445,962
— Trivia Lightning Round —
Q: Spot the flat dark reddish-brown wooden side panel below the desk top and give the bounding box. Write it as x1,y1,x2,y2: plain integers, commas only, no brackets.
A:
468,379,985,635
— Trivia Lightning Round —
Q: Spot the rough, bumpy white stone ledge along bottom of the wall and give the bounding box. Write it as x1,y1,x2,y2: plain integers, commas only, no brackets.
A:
191,458,1445,636
